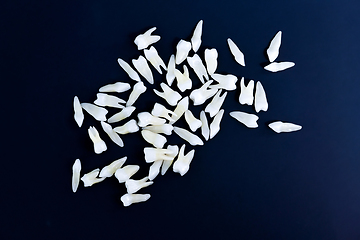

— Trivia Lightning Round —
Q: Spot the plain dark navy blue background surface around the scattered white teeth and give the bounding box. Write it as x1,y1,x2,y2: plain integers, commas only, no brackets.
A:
0,0,360,240
